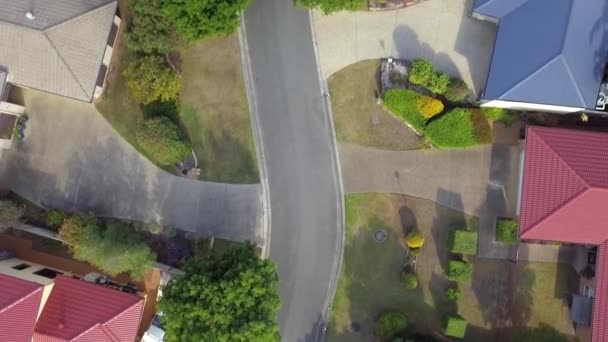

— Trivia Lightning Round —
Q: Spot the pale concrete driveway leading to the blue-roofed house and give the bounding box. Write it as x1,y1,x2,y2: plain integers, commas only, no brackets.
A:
313,0,496,93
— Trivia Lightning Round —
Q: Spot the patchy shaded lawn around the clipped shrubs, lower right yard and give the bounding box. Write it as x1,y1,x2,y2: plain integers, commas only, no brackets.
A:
328,194,578,341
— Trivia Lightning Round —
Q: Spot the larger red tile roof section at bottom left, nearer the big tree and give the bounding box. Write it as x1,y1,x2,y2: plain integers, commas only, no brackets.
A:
33,276,143,342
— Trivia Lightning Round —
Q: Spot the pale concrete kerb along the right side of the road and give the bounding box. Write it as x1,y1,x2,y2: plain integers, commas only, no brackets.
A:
308,10,346,340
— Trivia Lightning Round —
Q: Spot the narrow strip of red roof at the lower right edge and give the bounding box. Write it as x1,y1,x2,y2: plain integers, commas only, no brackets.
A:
591,242,608,342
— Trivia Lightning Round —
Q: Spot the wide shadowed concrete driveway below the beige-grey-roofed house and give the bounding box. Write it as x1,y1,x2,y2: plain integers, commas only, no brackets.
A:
0,91,263,244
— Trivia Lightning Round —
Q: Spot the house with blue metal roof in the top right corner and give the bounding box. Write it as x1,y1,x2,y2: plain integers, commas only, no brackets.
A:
472,0,608,113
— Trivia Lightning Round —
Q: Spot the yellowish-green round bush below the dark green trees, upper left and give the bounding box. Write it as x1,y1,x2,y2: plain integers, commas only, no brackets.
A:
124,55,182,104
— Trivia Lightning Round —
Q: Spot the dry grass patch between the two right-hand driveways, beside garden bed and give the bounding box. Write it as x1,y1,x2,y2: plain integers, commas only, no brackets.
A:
328,59,421,150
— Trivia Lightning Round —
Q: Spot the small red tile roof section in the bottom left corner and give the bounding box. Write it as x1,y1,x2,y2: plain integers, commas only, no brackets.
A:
0,274,42,342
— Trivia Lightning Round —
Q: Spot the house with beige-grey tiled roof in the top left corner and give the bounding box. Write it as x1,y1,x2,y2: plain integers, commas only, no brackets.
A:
0,0,120,102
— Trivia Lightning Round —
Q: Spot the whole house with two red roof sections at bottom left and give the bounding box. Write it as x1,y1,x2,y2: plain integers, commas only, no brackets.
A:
0,250,144,342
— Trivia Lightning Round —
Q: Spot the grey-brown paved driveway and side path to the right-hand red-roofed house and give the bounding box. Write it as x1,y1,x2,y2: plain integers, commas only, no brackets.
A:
340,144,586,264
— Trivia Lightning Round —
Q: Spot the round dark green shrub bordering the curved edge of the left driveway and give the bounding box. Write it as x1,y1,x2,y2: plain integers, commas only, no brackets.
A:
135,116,191,165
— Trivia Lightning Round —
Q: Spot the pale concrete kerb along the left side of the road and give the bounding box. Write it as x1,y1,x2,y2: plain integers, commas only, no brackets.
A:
238,11,272,259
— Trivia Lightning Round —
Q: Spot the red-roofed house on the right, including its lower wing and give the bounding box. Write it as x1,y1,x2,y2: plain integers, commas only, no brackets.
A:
519,126,608,342
